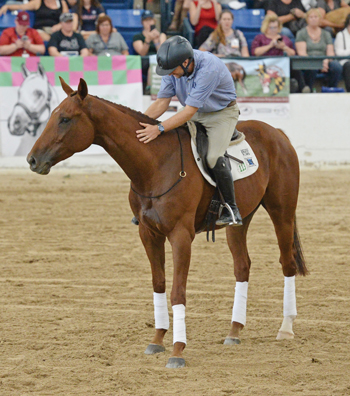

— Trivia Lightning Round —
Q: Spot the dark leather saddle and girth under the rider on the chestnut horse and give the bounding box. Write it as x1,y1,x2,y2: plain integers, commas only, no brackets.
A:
194,121,243,242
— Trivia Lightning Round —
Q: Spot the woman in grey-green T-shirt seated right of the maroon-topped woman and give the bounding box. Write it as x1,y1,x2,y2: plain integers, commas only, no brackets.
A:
295,8,342,89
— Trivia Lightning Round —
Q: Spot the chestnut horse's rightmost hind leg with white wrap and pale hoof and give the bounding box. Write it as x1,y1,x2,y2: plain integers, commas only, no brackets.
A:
262,183,298,340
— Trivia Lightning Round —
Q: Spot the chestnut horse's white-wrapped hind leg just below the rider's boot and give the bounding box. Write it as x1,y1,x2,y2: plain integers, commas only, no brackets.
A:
224,211,255,345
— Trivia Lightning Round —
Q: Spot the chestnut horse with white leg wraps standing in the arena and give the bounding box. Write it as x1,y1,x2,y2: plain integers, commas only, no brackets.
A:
27,79,307,367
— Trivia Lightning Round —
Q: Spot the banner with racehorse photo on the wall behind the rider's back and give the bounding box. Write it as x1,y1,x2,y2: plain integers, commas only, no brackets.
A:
150,56,290,120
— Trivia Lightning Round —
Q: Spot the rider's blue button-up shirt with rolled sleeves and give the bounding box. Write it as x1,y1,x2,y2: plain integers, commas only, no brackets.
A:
158,50,236,113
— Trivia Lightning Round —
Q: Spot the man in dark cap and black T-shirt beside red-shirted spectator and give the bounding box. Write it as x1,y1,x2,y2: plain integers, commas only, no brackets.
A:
48,12,89,56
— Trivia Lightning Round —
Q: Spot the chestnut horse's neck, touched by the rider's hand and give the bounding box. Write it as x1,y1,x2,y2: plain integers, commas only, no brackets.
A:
92,100,170,189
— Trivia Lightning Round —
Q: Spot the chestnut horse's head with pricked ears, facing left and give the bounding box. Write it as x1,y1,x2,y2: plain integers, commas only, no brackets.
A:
27,77,95,175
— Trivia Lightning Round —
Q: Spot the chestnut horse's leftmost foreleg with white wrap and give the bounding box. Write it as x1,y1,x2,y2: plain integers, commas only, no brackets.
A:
139,224,169,355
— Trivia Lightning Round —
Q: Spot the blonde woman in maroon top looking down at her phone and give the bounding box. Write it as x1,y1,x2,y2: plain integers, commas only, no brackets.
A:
251,15,311,93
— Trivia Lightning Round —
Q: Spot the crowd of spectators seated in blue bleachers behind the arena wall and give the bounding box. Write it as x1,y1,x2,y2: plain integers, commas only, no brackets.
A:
0,0,350,92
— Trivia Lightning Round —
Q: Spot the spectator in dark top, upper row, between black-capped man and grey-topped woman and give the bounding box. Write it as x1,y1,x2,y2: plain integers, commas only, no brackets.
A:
72,0,105,40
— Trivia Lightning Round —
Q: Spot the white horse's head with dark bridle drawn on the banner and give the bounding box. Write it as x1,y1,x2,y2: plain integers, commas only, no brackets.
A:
7,63,52,136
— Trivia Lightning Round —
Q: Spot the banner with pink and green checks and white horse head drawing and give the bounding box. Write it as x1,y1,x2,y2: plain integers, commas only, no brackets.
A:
0,56,142,156
